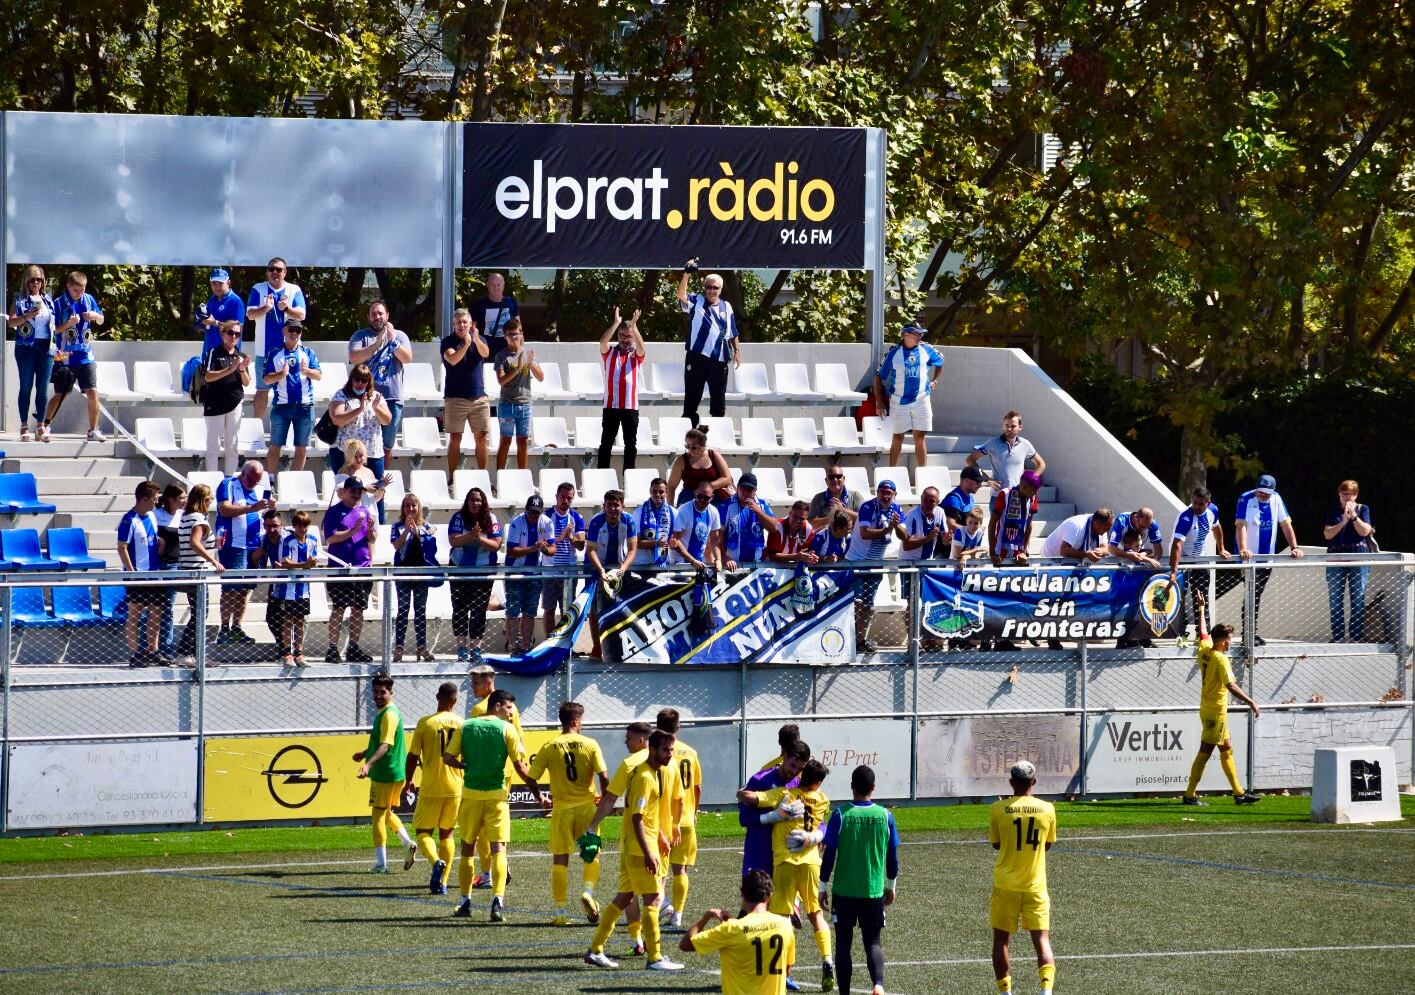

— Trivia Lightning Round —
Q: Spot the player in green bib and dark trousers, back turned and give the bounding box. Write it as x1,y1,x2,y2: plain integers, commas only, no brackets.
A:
819,764,899,995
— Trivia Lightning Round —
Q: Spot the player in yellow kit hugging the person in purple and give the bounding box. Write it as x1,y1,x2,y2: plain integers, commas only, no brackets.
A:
737,759,835,992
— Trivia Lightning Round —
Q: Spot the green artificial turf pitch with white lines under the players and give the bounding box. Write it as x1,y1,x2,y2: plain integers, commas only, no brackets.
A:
0,797,1415,995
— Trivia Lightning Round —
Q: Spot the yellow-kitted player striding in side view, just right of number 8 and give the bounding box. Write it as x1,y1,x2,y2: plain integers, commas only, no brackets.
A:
584,730,683,971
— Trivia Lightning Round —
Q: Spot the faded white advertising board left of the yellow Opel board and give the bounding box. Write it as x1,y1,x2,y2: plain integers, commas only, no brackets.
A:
6,740,197,829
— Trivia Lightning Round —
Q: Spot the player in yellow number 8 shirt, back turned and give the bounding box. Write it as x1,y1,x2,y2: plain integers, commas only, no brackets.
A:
531,702,608,926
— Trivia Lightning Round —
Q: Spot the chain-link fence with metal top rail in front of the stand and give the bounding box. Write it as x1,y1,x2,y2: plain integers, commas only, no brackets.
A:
0,555,1415,829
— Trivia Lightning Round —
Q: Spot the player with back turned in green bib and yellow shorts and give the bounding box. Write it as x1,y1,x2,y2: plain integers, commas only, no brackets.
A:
443,691,539,923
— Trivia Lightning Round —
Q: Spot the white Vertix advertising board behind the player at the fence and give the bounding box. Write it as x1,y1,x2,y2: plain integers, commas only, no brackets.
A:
1085,709,1248,793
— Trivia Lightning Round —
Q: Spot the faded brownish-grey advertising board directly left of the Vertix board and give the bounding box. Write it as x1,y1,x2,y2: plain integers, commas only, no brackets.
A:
918,715,1081,798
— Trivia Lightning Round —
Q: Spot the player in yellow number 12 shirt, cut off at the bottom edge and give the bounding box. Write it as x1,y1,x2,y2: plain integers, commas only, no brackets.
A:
678,870,795,995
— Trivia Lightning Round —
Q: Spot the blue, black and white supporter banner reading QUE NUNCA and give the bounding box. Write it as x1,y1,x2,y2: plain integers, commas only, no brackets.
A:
599,568,855,664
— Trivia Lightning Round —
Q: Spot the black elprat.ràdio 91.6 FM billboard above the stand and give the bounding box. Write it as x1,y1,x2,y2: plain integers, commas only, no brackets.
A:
461,123,866,269
